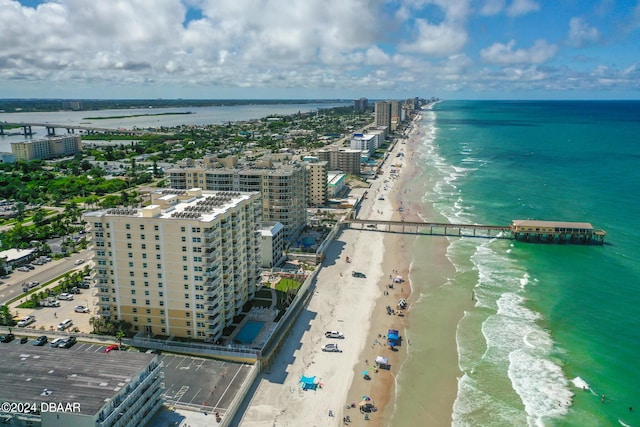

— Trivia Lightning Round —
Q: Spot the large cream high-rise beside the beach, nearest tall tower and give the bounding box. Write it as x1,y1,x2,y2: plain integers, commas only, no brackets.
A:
83,188,261,342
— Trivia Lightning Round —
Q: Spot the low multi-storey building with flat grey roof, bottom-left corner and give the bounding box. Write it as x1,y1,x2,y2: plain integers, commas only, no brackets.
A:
0,343,164,427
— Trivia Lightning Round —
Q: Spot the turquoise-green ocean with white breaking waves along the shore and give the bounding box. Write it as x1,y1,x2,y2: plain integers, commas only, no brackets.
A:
393,101,640,426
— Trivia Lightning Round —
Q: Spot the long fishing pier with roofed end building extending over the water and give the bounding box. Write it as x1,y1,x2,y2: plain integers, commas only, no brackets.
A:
344,219,607,245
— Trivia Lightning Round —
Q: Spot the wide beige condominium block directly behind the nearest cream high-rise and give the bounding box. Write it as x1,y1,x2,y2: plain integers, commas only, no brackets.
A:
166,163,307,240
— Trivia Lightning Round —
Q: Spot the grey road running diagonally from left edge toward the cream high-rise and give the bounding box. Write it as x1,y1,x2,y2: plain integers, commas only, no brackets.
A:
0,249,91,305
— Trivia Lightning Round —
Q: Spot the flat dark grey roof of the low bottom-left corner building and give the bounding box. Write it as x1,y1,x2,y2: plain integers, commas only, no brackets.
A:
0,341,157,415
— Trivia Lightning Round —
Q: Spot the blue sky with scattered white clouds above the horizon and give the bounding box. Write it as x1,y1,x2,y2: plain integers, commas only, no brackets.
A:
0,0,640,99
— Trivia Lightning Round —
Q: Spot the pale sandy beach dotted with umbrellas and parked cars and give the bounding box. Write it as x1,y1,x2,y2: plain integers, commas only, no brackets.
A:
241,112,457,427
